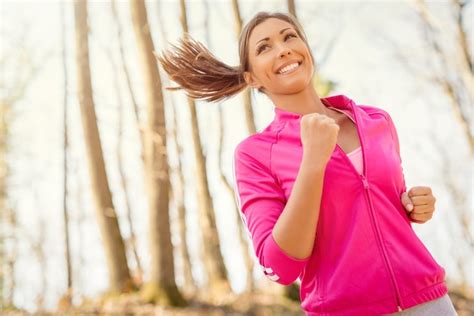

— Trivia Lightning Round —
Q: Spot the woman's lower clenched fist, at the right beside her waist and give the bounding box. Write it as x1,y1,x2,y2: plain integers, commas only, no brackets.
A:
401,186,436,224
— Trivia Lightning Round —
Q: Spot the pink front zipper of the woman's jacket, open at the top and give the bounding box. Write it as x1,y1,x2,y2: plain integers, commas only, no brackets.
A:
330,103,402,312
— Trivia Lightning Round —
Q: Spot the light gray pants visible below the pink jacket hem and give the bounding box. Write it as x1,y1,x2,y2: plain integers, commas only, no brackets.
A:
387,294,457,316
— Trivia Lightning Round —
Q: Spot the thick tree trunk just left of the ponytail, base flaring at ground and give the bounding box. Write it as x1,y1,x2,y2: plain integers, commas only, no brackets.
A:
130,0,186,306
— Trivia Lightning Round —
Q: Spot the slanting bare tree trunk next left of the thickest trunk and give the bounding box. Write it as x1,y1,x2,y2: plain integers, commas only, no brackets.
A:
74,0,132,292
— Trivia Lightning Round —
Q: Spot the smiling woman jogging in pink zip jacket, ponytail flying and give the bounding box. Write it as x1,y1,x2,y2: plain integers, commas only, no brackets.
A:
157,12,456,315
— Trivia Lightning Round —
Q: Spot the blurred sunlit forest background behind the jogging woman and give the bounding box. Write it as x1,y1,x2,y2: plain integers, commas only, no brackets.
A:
0,0,474,315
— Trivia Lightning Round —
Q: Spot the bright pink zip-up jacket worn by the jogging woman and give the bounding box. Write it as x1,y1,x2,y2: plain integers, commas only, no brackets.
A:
233,95,448,316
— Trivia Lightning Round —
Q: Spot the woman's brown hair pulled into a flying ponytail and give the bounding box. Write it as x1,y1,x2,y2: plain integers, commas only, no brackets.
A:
155,11,314,102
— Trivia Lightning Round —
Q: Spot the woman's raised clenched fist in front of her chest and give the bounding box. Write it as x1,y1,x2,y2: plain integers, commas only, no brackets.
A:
300,113,339,167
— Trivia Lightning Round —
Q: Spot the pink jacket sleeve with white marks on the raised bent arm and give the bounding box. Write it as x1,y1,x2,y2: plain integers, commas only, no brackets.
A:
233,143,309,285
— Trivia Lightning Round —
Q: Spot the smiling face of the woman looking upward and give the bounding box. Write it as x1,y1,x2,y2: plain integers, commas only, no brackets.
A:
244,18,313,96
